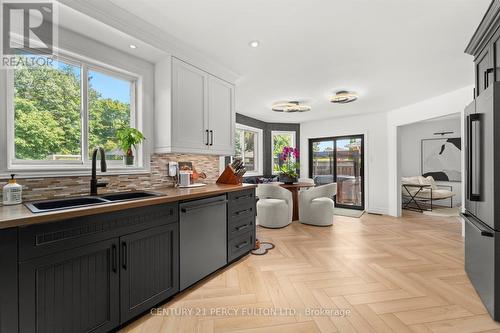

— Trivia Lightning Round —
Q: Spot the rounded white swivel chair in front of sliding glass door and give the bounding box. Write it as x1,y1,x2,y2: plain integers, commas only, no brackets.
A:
299,183,337,226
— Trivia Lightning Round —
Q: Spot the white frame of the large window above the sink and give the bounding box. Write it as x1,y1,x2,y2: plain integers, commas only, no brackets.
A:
5,50,141,173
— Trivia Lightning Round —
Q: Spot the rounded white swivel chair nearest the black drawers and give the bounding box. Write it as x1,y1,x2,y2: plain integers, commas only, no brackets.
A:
256,184,293,228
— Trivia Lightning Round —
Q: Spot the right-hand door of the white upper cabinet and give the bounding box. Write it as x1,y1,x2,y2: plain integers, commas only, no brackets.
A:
208,76,235,155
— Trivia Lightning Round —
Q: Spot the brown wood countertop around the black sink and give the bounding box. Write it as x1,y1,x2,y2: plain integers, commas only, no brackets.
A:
0,184,257,229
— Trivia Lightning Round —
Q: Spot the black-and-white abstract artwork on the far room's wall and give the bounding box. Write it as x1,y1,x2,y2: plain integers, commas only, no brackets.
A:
421,138,462,182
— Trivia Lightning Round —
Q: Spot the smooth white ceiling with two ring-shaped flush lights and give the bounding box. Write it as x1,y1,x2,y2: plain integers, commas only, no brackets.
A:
103,0,490,122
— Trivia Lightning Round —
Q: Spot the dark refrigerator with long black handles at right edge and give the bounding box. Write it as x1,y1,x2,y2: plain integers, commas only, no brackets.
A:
463,82,500,321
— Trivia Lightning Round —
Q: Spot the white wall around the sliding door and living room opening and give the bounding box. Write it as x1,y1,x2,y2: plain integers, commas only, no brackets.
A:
300,86,472,216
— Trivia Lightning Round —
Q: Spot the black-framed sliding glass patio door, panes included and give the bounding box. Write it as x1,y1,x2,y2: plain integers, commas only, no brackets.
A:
309,135,365,209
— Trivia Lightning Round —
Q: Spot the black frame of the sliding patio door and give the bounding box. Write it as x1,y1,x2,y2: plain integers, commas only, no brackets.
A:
308,134,365,210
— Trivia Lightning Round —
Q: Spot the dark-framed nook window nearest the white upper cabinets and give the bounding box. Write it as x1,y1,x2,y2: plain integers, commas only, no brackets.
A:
234,124,262,176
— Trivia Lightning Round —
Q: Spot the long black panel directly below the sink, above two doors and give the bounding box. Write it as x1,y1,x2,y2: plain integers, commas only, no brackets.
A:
19,203,178,261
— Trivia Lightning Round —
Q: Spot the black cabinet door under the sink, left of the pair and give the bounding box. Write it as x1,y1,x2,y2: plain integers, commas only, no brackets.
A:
19,239,119,333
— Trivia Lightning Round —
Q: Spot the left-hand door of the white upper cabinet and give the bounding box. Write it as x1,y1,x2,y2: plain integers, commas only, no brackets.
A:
172,58,209,153
